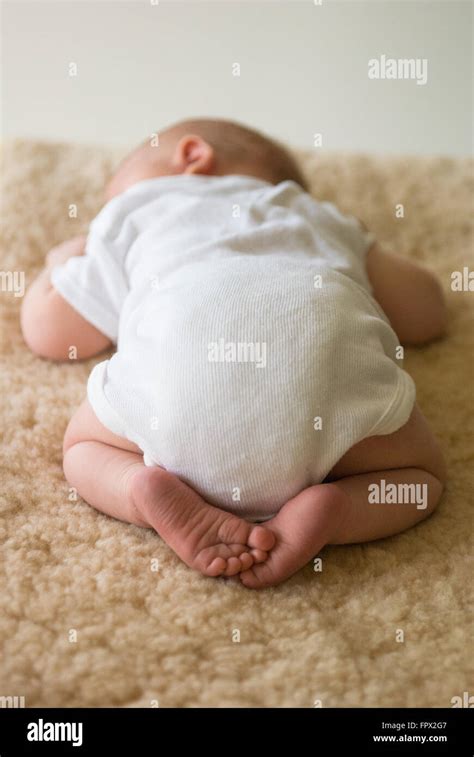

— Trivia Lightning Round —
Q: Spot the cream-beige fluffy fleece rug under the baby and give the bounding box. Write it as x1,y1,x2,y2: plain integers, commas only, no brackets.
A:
0,142,474,707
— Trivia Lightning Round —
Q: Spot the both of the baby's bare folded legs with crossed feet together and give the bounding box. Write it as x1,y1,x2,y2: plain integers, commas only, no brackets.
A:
64,400,445,588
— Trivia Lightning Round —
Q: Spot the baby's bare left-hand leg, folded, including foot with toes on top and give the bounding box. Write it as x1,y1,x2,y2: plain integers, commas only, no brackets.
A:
63,400,275,576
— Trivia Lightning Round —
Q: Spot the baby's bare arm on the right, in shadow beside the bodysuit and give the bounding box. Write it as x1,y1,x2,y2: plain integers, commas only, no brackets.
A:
367,244,446,344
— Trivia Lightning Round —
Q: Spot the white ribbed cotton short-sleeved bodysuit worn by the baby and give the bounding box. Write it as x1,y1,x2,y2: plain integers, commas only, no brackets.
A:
51,175,415,521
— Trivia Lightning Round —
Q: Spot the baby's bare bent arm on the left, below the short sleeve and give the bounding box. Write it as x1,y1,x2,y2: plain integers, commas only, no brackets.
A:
21,236,111,361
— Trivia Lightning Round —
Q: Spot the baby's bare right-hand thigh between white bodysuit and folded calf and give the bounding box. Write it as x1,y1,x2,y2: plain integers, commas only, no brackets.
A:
326,405,446,481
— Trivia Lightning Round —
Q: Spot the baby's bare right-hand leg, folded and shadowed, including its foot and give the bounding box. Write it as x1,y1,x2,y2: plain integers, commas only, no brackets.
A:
240,408,445,589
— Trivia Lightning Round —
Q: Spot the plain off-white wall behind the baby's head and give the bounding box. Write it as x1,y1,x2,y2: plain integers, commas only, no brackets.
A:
1,0,472,155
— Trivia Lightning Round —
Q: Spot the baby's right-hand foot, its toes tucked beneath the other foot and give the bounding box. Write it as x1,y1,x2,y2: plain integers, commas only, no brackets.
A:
239,484,347,589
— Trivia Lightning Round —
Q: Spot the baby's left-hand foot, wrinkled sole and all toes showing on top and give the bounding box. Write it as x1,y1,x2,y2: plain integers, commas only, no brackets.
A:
130,467,275,576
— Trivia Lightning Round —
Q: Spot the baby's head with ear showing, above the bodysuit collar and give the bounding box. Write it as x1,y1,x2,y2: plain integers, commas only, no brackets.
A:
105,118,308,200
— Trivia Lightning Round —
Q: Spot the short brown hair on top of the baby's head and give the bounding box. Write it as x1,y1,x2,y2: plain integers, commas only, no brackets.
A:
162,118,309,191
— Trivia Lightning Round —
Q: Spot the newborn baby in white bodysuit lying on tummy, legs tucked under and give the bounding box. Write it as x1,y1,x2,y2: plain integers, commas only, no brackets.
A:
22,119,445,588
